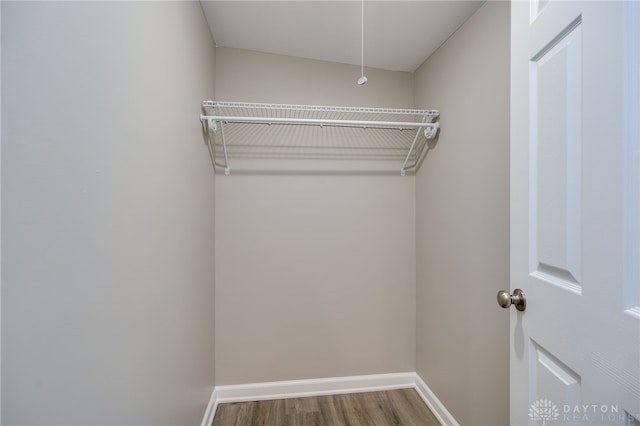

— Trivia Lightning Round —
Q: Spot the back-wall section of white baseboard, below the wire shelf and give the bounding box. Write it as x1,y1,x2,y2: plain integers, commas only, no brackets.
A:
216,373,415,402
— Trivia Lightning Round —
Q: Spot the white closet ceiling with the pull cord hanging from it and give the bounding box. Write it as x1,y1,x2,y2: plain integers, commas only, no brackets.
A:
202,0,483,72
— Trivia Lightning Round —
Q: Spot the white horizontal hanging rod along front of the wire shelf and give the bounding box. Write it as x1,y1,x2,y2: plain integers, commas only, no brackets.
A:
200,115,439,130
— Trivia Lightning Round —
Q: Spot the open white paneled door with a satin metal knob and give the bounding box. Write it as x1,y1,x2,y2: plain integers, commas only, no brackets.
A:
510,0,640,426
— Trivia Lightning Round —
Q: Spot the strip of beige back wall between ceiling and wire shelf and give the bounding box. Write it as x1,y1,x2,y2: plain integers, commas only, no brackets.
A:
216,47,413,108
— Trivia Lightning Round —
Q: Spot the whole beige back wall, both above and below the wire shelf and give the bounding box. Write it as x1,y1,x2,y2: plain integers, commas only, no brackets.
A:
216,48,415,385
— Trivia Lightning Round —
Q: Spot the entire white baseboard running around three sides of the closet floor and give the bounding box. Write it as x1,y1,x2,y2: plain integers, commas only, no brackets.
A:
202,372,459,426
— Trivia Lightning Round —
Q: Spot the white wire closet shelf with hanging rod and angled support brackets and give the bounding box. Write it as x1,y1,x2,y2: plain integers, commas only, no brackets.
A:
200,101,439,176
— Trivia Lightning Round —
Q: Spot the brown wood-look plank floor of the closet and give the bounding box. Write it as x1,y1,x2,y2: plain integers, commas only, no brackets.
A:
212,389,440,426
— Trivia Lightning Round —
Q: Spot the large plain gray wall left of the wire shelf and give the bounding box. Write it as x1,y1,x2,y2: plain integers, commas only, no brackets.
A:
2,2,215,425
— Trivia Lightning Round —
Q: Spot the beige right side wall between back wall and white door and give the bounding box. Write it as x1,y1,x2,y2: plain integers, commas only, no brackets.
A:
415,2,510,425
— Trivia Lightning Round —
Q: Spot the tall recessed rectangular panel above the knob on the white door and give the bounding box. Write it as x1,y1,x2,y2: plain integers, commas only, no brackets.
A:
529,20,582,294
